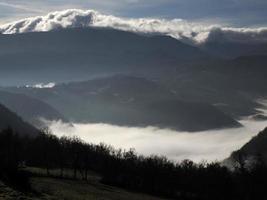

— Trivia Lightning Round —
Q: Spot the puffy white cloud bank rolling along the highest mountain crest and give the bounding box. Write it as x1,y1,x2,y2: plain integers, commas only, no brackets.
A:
0,9,267,43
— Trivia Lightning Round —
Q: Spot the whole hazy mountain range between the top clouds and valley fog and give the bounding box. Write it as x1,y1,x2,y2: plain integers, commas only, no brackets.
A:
0,28,267,131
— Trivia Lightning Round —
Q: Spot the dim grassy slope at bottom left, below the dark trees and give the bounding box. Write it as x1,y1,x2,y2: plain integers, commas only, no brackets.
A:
0,168,168,200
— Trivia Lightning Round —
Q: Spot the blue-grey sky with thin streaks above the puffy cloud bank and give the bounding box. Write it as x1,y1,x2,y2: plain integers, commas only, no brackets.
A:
0,0,267,27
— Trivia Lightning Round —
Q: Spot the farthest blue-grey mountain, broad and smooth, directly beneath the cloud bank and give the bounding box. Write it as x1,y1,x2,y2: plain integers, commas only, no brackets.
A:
0,28,209,85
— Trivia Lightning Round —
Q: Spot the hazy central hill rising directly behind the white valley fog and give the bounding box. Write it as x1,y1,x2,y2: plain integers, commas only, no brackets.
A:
5,75,240,131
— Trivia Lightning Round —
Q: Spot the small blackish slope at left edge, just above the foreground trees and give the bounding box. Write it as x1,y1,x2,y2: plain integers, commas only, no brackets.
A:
0,104,39,136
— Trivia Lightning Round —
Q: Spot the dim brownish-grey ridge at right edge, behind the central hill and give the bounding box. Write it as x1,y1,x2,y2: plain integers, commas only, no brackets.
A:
155,55,267,119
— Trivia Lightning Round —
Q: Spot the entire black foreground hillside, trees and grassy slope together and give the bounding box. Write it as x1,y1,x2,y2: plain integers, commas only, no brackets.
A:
0,129,267,200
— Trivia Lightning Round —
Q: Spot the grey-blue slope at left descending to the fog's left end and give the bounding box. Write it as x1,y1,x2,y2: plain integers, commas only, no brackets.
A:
0,91,67,127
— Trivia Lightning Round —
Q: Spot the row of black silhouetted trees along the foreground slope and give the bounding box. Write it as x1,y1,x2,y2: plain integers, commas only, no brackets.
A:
0,129,267,199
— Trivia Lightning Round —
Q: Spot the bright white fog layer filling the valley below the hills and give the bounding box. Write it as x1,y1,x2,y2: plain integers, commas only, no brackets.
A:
48,117,266,162
